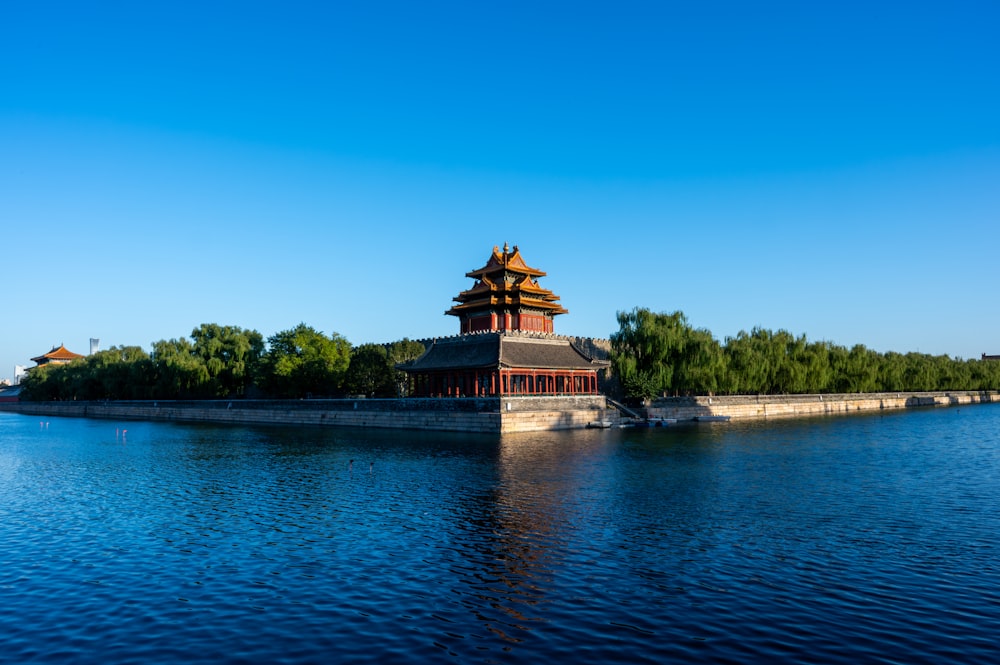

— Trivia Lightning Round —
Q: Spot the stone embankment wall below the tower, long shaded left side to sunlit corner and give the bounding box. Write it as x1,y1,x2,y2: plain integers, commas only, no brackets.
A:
0,396,618,434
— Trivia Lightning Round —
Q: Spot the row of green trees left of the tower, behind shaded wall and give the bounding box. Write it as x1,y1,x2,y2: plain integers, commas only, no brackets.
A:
22,323,424,400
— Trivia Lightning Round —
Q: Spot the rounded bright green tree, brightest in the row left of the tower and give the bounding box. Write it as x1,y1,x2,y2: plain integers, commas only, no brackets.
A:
259,323,351,398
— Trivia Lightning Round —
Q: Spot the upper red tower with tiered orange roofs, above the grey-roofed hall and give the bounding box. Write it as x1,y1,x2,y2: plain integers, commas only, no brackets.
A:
445,243,568,335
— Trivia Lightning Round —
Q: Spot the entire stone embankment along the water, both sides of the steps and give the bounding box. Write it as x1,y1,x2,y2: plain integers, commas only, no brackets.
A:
0,391,1000,434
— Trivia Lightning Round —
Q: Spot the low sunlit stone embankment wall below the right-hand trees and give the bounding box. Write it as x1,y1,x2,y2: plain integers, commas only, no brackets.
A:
646,391,1000,420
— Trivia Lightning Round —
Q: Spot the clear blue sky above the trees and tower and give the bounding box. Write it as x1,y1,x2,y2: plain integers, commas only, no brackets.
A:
0,0,1000,378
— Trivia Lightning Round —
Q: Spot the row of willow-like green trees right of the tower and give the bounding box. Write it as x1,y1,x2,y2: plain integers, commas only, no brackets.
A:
611,308,1000,398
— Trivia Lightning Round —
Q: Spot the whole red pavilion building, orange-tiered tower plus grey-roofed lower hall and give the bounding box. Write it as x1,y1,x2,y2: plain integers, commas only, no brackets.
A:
400,244,609,397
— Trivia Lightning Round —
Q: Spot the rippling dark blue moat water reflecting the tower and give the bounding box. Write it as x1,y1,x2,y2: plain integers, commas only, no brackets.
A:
0,405,1000,663
